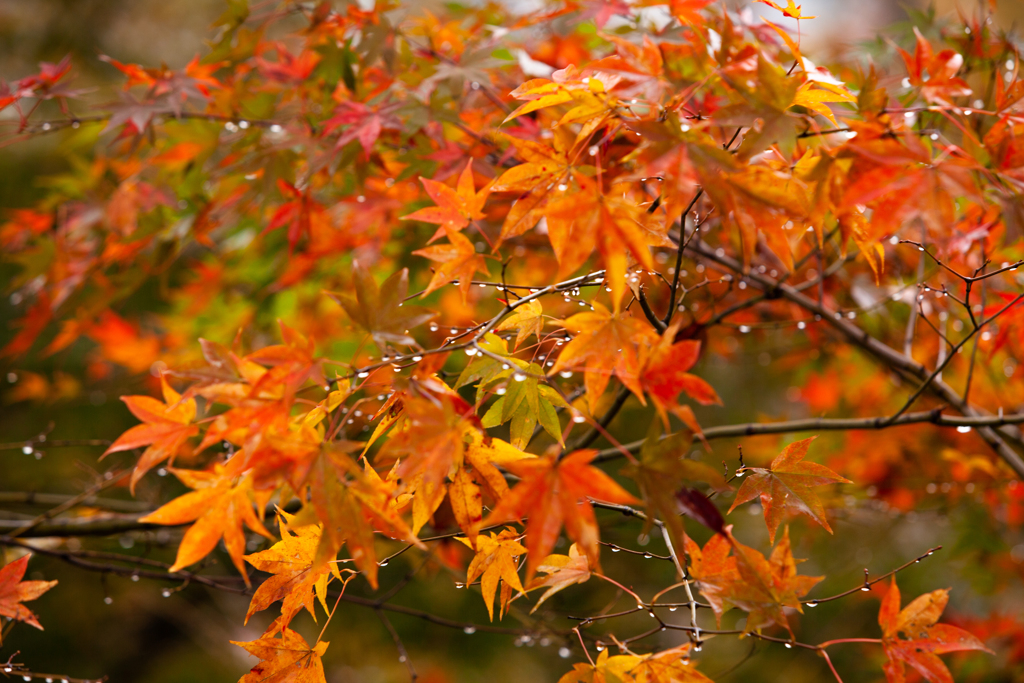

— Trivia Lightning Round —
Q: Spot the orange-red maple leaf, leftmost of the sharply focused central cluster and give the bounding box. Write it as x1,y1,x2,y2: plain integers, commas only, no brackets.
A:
103,376,199,494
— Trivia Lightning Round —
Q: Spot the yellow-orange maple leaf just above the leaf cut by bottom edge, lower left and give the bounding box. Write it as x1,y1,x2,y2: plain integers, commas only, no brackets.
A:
245,510,341,626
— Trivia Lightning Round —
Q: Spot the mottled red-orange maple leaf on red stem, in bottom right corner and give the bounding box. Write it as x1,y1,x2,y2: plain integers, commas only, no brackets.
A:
879,577,992,683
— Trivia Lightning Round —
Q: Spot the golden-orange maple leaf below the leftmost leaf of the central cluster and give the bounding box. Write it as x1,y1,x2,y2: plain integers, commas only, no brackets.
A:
139,466,273,586
